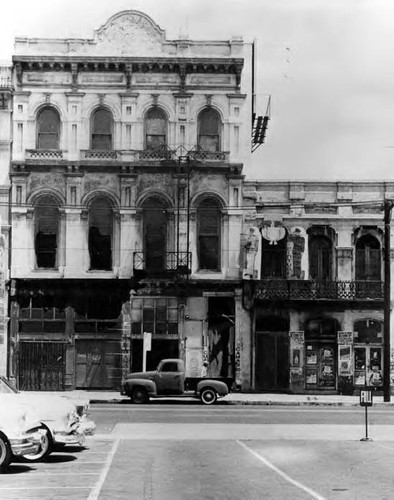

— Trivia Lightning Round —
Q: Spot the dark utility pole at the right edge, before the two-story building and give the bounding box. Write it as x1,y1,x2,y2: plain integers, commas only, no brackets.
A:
383,200,394,402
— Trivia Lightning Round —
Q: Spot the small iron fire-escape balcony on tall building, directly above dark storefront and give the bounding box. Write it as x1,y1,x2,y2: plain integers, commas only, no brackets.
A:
133,252,192,278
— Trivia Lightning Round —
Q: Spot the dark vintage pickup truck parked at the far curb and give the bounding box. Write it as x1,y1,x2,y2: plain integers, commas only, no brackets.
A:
121,359,233,405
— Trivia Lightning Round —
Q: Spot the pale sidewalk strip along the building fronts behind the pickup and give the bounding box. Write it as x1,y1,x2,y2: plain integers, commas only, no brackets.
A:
20,390,394,406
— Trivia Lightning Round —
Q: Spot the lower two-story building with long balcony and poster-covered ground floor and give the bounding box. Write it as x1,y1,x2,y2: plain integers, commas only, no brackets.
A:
243,181,394,394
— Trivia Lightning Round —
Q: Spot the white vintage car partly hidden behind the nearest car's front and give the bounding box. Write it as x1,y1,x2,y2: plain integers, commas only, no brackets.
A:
0,377,96,462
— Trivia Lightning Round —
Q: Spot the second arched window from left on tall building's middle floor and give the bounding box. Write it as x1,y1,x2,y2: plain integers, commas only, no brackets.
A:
89,196,113,271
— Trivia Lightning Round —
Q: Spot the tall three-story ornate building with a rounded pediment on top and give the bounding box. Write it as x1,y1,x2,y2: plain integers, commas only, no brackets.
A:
9,11,252,389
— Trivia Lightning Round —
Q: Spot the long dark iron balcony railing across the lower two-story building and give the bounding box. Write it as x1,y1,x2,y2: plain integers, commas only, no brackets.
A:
254,279,383,300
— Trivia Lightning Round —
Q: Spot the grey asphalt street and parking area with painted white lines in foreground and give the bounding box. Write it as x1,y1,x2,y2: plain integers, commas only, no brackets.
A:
0,404,394,500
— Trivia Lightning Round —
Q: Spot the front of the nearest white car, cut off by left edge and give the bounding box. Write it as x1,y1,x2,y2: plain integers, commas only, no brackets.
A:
0,402,47,474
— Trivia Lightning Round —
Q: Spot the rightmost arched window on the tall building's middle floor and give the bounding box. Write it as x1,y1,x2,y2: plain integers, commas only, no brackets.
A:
197,198,221,271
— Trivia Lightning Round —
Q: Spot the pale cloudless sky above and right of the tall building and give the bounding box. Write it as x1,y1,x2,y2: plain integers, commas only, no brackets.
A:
0,0,394,181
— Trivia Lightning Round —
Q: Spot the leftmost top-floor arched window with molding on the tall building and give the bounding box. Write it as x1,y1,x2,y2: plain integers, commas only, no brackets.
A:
35,103,62,150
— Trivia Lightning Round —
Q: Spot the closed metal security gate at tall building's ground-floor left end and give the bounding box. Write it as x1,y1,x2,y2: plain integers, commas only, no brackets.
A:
18,341,66,391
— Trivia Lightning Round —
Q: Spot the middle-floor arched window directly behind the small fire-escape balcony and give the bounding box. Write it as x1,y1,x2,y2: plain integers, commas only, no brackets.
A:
143,198,168,273
